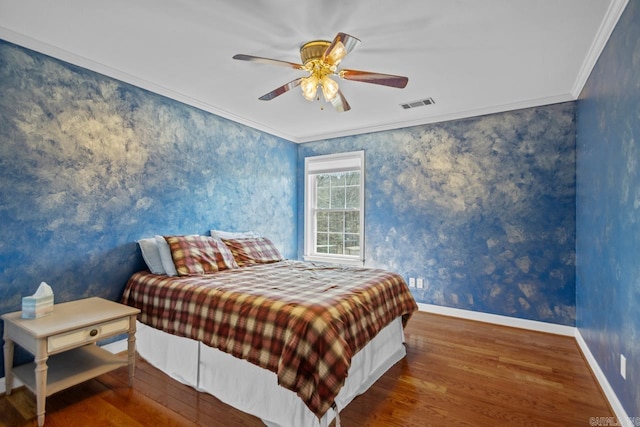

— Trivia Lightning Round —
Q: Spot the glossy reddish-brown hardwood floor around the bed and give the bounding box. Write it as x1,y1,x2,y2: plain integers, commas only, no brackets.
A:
0,313,613,427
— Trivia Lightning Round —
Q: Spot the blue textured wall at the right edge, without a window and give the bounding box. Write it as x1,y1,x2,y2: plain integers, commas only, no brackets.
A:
576,1,640,417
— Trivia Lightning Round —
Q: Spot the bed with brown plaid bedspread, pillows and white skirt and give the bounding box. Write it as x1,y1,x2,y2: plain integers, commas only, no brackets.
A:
123,236,417,427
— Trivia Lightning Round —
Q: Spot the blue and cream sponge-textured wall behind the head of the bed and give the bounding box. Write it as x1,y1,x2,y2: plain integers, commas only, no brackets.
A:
0,41,297,377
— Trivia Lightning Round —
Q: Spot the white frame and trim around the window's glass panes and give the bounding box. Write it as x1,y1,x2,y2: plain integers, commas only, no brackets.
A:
304,151,365,266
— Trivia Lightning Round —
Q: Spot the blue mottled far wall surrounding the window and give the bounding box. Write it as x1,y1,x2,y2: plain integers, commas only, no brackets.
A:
298,103,575,326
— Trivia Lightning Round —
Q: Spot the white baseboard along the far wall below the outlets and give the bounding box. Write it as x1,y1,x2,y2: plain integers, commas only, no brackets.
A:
418,303,576,337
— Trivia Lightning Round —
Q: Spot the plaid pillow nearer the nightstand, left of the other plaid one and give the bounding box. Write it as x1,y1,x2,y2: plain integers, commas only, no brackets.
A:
165,235,238,276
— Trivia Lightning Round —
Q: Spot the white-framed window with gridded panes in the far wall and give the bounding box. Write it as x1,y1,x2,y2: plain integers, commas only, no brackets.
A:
304,151,364,265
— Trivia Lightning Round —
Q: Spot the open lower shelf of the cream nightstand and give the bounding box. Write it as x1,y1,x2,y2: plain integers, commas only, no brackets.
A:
13,344,128,396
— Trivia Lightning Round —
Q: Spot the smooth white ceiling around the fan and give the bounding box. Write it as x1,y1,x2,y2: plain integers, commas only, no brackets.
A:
0,0,628,142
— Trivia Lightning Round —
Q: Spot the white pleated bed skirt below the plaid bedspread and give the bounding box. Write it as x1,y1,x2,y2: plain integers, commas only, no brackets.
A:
136,318,406,427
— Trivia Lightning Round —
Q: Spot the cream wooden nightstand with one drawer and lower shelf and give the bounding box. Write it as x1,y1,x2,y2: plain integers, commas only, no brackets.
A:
2,298,140,426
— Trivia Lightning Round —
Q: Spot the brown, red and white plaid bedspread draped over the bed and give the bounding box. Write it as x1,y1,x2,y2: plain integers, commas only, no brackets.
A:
123,261,417,417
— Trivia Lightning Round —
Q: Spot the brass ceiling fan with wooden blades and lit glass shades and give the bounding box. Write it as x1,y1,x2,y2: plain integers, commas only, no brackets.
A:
233,33,409,112
